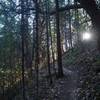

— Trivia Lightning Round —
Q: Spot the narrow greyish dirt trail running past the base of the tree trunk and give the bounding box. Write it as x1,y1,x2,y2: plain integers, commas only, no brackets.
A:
59,68,77,100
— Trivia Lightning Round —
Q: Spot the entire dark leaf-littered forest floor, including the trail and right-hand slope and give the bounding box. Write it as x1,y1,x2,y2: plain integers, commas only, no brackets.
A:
4,49,100,100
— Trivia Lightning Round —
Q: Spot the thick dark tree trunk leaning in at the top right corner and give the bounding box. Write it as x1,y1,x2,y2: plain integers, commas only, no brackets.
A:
77,0,100,50
